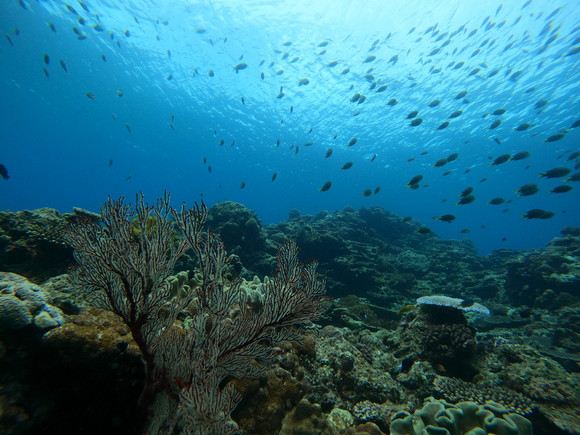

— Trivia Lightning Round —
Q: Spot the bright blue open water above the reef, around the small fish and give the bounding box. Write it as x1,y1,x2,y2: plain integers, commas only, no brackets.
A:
0,0,580,254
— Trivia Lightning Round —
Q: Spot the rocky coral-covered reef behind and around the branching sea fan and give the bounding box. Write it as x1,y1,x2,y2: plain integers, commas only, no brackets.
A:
0,203,580,435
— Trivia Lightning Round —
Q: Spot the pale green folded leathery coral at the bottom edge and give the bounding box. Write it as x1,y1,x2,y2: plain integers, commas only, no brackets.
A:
390,397,532,435
